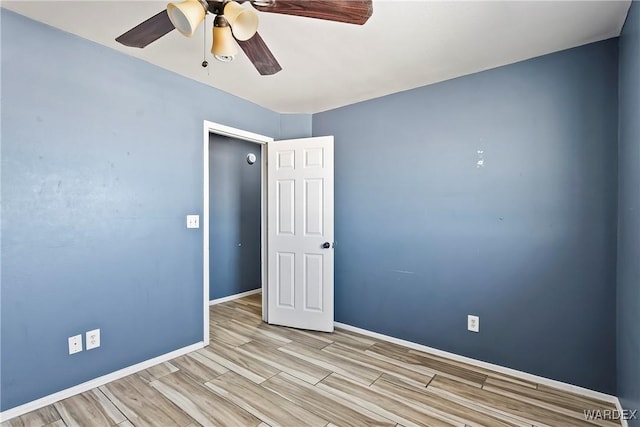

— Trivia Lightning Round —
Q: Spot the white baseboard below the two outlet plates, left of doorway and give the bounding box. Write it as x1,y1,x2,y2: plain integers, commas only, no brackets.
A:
0,341,204,422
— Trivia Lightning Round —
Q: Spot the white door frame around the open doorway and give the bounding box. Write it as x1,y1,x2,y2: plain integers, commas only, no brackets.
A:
202,120,273,345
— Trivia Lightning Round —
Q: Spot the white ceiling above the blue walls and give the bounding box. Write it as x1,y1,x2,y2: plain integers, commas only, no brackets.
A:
2,0,630,113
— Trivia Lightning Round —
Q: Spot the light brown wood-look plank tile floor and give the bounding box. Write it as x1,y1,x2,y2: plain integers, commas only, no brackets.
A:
2,294,620,427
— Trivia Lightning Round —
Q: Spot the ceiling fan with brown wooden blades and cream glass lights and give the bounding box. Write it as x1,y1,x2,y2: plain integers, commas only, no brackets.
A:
116,0,373,75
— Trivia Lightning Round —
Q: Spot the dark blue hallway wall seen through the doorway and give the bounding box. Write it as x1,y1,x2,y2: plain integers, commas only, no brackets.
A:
209,135,262,299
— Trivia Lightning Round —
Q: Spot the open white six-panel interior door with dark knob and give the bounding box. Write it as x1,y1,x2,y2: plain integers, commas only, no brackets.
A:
267,136,334,332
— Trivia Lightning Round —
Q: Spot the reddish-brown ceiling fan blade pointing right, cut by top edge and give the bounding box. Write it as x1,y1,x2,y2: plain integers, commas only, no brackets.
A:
252,0,373,25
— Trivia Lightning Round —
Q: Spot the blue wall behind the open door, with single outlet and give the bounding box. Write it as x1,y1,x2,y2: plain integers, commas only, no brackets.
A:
313,40,618,393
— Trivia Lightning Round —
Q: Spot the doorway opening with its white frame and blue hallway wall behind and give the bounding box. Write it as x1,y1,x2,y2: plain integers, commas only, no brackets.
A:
202,121,273,345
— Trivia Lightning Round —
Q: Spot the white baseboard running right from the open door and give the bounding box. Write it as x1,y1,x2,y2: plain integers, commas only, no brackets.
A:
334,322,620,409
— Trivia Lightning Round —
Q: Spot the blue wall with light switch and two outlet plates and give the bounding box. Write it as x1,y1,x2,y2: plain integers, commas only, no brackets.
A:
0,9,281,411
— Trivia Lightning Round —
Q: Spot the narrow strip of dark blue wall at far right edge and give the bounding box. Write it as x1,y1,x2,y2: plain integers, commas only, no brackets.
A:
617,2,640,426
